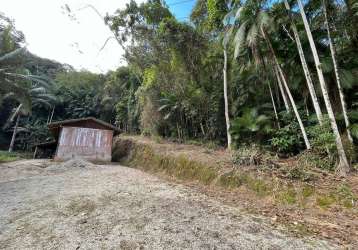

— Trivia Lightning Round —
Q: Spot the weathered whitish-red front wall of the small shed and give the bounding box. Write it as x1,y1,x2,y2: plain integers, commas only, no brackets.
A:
55,127,113,162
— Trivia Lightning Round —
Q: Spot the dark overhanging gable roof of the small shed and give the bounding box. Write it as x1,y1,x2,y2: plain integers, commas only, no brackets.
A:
47,117,120,137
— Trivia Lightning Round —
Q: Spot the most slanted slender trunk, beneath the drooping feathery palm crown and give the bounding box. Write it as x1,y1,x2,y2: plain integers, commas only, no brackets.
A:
261,27,311,149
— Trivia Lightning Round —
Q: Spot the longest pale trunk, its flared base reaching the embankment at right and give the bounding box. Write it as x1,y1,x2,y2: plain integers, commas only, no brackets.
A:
297,0,349,176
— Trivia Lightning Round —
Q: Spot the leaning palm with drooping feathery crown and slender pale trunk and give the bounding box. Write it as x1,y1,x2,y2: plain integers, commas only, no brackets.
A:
234,1,311,149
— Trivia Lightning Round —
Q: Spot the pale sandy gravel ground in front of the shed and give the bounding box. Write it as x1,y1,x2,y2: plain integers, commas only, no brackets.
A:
0,160,336,250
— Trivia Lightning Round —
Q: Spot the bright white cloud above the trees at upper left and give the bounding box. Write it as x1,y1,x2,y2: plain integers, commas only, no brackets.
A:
0,0,143,73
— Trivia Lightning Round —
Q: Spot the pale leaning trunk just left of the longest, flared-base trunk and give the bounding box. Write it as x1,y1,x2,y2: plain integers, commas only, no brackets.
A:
284,0,323,125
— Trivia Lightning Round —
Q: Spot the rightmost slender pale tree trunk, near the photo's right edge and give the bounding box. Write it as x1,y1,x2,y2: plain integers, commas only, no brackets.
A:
322,0,353,143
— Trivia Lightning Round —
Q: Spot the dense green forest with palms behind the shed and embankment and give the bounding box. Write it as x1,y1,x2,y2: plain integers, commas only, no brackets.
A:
0,0,358,175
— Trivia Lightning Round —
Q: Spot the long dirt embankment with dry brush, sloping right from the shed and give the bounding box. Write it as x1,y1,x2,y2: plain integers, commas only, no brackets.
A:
113,136,358,248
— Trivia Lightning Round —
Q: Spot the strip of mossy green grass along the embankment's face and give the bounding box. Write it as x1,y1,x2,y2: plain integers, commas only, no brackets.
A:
116,138,357,209
